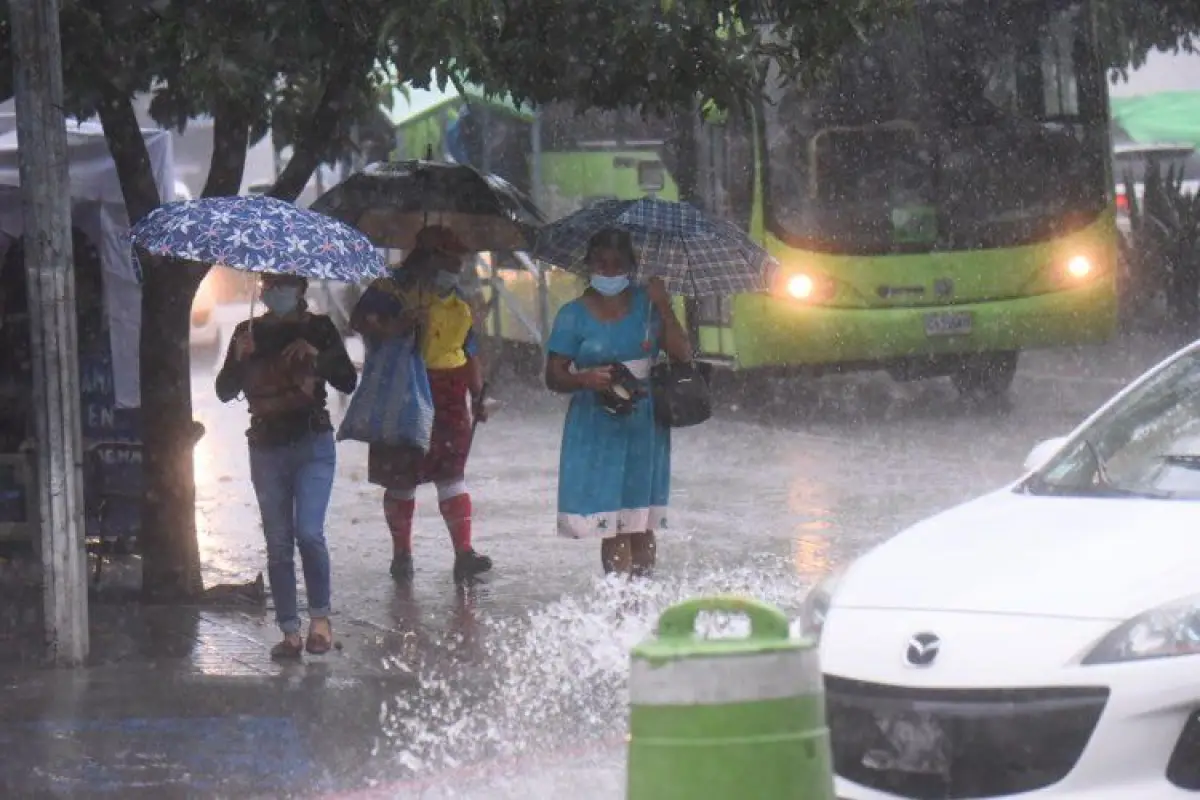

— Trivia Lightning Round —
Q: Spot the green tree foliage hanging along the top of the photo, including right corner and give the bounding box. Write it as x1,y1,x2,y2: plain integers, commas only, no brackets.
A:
0,0,1200,183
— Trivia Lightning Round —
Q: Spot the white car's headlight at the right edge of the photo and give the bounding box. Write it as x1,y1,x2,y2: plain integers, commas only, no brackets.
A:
1084,595,1200,666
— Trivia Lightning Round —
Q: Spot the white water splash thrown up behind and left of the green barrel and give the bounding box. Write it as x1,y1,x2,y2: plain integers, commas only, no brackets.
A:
370,559,804,800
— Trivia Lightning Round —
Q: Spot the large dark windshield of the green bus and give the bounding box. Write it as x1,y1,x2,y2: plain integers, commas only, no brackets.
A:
762,0,1109,254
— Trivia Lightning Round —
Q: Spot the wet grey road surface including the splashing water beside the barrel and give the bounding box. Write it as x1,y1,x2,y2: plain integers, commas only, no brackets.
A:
182,311,1171,799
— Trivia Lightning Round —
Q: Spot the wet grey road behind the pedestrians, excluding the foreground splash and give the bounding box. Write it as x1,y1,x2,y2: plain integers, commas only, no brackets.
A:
193,331,1169,606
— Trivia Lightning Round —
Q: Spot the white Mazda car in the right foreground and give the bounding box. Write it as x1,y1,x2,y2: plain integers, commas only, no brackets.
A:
802,343,1200,800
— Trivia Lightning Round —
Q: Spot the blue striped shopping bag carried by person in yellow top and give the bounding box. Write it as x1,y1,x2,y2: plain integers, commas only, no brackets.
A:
337,336,433,452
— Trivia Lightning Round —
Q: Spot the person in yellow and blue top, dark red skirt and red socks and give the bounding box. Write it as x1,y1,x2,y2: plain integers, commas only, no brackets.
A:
350,225,492,582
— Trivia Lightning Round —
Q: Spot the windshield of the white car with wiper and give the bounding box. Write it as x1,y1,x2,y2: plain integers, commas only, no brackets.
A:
1022,351,1200,500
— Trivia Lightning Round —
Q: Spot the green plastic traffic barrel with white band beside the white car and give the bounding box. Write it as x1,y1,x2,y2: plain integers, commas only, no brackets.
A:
625,596,834,800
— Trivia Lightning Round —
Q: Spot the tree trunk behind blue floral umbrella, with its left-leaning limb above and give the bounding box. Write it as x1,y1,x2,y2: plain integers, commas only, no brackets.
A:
100,86,204,601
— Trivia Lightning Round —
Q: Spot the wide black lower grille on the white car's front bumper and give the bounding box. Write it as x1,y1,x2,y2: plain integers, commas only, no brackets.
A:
826,675,1109,800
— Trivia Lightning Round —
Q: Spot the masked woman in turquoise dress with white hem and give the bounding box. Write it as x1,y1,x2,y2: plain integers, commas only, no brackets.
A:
546,229,691,576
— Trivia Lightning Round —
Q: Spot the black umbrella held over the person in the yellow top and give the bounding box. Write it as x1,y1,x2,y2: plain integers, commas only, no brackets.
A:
312,161,544,252
